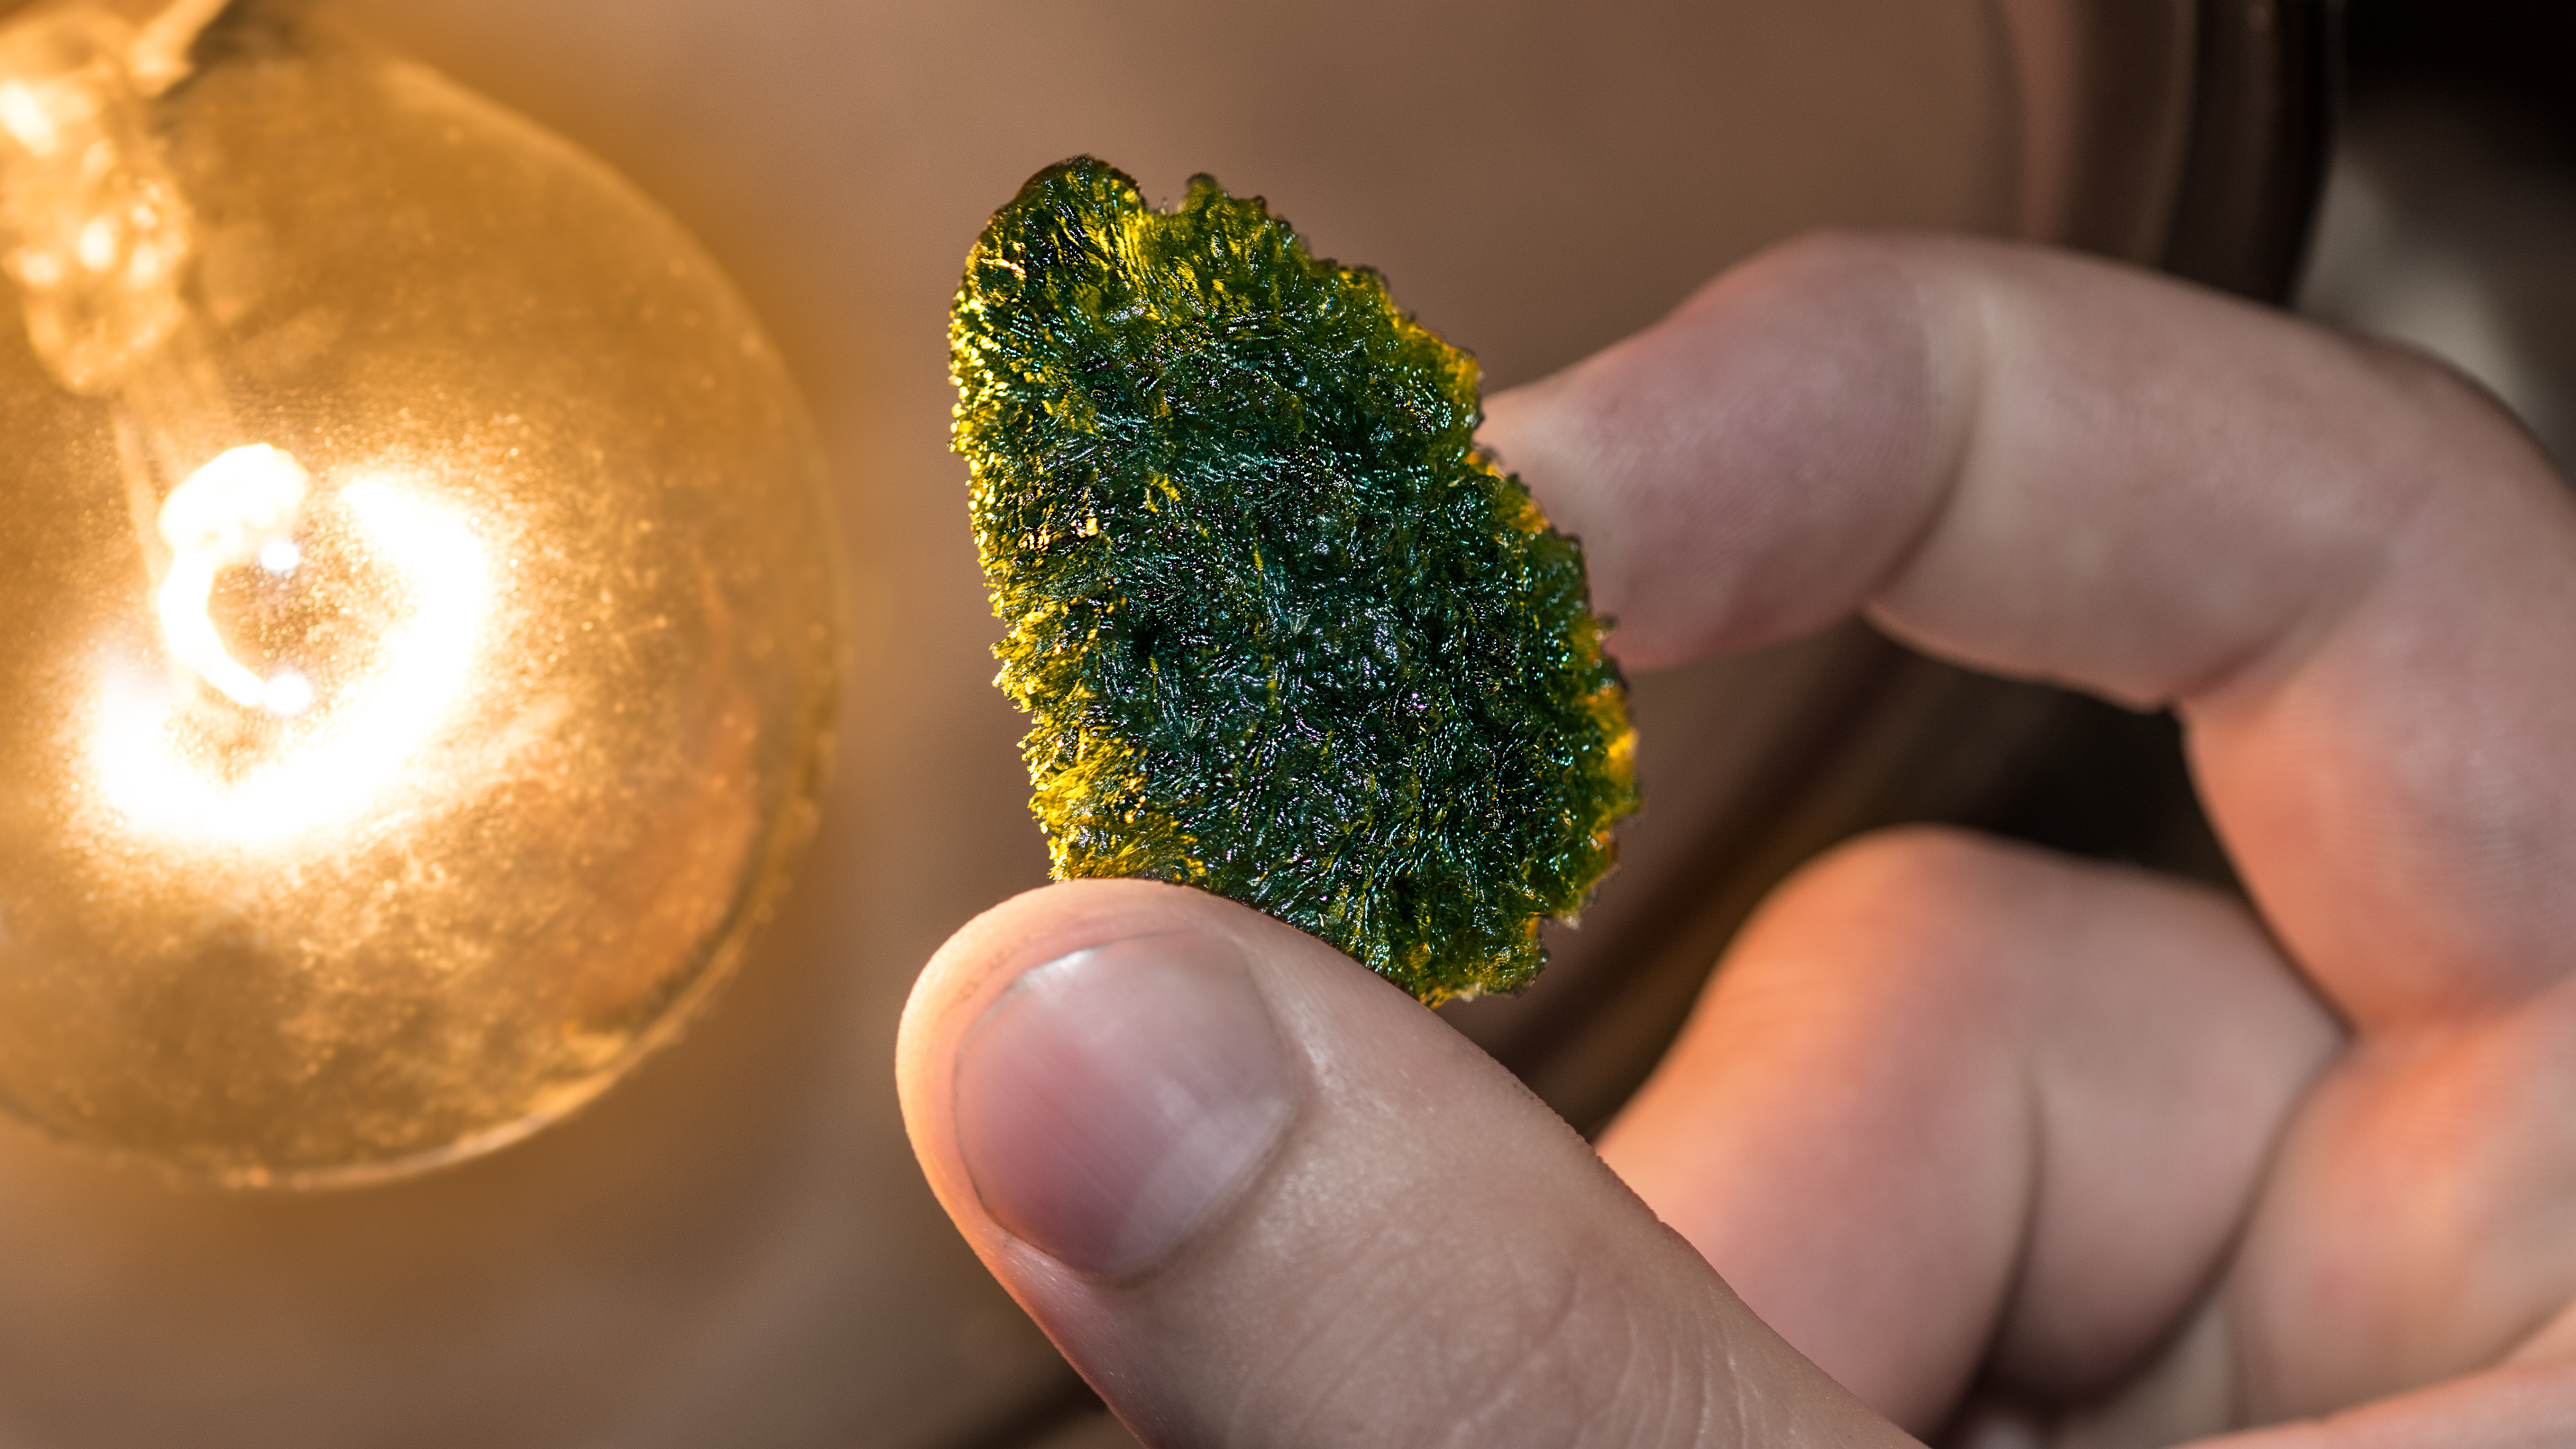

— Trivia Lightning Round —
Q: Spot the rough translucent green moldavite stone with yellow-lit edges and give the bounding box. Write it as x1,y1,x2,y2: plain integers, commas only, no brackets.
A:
948,157,1636,1003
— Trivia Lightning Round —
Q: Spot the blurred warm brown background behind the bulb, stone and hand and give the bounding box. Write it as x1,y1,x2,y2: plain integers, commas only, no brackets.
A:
0,0,2576,1449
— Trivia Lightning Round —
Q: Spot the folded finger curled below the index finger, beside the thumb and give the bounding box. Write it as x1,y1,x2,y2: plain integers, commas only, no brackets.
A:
1602,830,2339,1433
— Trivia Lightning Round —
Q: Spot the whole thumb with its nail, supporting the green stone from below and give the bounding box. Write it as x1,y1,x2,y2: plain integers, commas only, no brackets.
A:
896,882,1912,1446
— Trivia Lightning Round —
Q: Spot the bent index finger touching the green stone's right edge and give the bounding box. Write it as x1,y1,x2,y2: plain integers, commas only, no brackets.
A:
1487,237,2576,1029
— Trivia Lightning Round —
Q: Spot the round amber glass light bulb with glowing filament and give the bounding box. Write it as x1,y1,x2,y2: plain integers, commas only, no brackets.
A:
0,0,837,1186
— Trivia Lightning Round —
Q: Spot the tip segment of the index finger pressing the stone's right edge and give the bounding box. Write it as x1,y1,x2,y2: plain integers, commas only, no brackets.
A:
1479,232,1955,668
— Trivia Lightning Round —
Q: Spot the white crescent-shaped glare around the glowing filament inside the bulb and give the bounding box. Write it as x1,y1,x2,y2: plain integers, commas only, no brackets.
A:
93,474,492,846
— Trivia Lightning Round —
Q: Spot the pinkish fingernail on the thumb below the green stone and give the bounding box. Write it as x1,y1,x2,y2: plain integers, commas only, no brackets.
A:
956,933,1298,1276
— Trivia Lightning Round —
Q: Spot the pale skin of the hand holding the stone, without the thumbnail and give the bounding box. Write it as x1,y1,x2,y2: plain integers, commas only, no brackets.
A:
899,237,2576,1449
